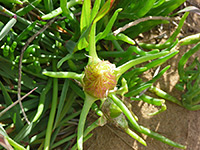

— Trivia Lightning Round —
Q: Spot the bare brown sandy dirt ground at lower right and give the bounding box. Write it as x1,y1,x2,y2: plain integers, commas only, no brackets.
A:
84,0,200,150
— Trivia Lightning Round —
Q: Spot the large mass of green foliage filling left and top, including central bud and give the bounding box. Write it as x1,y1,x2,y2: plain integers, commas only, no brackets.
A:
0,0,200,150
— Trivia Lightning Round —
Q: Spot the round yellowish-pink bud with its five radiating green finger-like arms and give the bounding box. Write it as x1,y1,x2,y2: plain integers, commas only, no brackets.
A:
43,24,169,150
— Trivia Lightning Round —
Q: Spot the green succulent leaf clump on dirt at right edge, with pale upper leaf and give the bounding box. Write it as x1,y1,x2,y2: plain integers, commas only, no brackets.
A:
156,34,200,111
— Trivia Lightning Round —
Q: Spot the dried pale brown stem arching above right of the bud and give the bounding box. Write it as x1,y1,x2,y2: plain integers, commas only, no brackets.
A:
113,16,170,36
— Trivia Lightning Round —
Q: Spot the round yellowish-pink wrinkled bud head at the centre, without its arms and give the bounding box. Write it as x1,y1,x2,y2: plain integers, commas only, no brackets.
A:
83,61,117,98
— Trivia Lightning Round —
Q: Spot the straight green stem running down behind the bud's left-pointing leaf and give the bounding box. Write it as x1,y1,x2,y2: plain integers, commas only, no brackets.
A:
44,60,58,150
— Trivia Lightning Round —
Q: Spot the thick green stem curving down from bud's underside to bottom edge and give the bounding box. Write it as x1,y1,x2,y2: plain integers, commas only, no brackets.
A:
77,93,96,150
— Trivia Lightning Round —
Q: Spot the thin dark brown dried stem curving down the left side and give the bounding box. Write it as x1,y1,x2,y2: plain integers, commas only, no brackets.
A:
17,17,57,124
